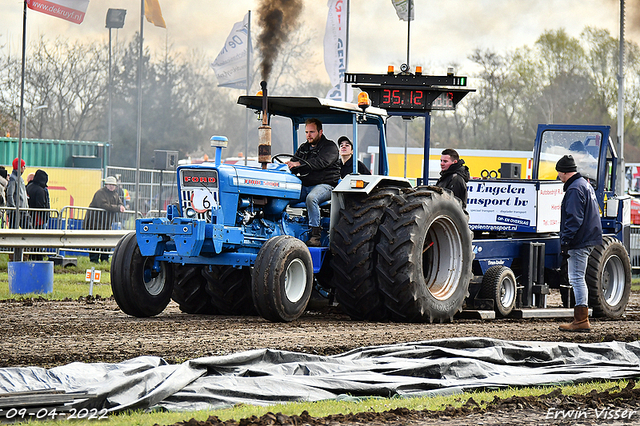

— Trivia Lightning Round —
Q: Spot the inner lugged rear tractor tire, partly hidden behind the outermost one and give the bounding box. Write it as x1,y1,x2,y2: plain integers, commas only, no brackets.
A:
331,188,398,321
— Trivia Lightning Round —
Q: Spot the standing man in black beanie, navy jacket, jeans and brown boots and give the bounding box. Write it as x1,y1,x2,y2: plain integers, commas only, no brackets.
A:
556,155,602,332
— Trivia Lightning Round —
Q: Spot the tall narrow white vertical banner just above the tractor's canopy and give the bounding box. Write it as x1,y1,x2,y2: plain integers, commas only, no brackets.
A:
324,0,353,102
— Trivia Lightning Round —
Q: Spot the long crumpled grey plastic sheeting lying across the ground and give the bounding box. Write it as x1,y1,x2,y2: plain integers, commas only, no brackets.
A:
0,338,640,412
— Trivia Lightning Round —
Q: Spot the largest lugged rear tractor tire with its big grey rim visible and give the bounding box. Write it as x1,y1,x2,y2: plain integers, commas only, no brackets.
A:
376,187,473,322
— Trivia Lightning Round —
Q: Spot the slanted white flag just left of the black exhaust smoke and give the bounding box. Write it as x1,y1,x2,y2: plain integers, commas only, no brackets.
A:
211,13,251,89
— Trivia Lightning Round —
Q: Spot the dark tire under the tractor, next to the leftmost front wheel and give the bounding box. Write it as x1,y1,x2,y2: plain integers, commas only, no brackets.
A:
171,264,218,315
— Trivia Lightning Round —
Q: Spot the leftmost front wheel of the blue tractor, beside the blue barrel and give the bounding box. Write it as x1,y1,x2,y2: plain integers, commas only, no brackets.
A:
111,233,173,318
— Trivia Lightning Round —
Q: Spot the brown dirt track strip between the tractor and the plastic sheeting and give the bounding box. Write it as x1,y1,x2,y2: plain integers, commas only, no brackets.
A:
0,292,640,367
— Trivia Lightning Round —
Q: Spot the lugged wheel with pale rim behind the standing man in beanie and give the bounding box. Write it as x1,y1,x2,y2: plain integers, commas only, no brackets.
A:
585,236,631,318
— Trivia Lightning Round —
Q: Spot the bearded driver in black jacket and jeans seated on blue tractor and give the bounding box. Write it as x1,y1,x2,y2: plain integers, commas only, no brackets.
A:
287,118,340,247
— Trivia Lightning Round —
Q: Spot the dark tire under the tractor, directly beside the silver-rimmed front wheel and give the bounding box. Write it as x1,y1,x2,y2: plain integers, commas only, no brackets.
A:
202,265,257,315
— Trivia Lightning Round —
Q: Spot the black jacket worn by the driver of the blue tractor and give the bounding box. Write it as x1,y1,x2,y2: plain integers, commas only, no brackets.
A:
291,135,340,186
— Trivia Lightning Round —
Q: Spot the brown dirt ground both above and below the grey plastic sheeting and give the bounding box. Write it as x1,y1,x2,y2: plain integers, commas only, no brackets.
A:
0,292,640,426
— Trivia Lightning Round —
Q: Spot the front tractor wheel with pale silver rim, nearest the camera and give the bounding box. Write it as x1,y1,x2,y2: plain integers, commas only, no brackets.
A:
251,235,313,322
